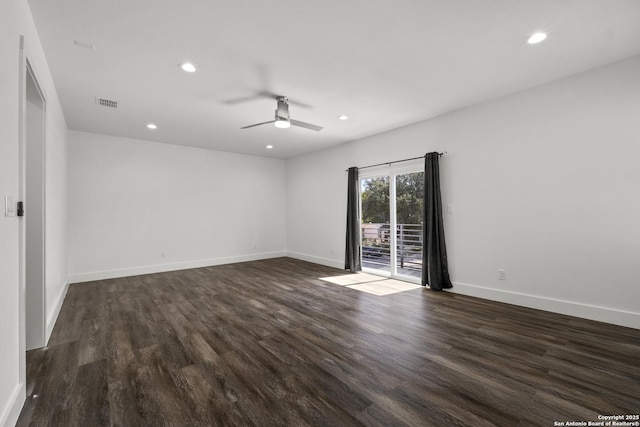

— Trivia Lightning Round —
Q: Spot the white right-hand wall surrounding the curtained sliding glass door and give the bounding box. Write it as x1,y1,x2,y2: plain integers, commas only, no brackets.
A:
287,56,640,328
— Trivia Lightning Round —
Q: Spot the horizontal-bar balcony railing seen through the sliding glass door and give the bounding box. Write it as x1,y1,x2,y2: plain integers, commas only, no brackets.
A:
362,223,422,277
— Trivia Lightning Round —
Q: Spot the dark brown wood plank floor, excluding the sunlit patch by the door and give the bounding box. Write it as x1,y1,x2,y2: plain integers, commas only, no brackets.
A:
18,258,640,426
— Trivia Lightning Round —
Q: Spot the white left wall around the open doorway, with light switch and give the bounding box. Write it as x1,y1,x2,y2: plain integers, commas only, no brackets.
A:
0,0,67,426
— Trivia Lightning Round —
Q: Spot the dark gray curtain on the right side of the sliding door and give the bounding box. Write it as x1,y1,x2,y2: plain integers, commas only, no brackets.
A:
421,153,453,291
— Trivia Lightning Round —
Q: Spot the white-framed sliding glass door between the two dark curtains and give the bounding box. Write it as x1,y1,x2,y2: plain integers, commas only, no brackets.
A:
360,171,423,281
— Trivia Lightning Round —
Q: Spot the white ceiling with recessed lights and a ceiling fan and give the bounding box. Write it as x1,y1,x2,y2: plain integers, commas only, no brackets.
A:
29,0,640,158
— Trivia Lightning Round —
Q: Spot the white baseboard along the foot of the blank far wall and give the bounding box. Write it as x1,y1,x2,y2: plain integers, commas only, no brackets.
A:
69,251,287,283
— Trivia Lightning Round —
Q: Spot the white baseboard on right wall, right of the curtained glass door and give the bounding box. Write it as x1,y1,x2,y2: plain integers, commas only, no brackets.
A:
447,282,640,329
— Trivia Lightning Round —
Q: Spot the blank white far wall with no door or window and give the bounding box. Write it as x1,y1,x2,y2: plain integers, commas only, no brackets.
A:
69,131,286,282
